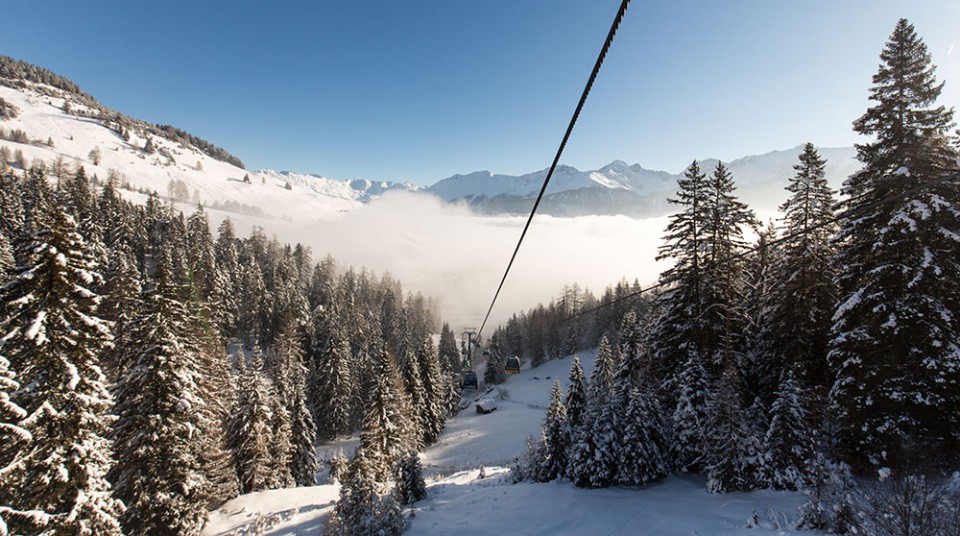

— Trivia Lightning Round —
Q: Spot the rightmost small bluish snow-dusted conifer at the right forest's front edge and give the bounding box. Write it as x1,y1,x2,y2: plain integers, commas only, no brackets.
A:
764,365,816,490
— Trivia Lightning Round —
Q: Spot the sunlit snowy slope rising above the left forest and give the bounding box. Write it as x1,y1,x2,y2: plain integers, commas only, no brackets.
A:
0,78,413,221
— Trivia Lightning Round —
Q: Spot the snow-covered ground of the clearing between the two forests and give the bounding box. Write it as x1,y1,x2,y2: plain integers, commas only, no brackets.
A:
203,353,804,536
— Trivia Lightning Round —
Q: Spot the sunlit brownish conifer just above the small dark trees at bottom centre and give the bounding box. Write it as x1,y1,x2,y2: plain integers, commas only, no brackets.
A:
360,350,417,480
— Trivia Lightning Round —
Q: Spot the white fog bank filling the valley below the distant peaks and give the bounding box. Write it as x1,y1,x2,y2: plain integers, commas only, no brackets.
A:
211,192,776,334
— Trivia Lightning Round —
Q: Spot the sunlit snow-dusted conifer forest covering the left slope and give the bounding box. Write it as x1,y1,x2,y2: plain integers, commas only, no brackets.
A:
0,161,459,534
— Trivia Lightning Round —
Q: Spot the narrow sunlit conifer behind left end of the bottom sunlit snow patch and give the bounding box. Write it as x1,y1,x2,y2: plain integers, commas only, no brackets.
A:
229,345,273,493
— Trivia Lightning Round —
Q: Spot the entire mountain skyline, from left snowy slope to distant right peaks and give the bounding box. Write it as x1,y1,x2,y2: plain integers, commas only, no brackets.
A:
0,56,858,221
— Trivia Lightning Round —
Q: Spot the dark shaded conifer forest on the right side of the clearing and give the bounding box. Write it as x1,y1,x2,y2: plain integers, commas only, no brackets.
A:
501,20,960,534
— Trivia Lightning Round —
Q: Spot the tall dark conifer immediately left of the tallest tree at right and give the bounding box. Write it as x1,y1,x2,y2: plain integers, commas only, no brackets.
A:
759,143,837,403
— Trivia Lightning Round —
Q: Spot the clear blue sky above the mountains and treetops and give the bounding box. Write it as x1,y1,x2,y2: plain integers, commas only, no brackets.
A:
0,0,960,184
